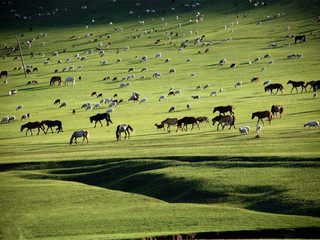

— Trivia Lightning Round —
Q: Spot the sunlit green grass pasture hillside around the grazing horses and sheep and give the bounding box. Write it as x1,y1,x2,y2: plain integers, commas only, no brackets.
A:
0,0,320,239
